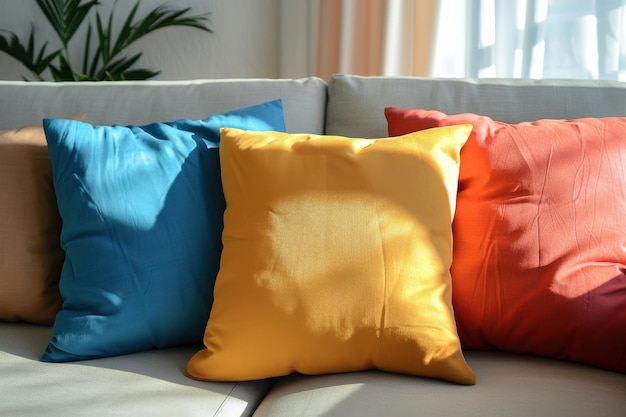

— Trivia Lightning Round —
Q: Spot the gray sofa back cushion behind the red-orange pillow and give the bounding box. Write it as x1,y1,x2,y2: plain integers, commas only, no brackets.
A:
326,74,626,138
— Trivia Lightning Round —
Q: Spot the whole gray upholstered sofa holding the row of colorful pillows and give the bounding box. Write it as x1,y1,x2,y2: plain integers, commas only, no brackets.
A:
0,75,626,417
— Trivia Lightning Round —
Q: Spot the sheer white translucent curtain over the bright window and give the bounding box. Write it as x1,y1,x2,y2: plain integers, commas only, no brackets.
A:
431,0,626,80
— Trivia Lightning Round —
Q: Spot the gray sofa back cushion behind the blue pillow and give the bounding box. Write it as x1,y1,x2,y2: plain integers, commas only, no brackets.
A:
0,78,326,133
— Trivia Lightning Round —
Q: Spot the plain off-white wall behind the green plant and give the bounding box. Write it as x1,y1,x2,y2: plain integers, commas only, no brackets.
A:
0,0,280,80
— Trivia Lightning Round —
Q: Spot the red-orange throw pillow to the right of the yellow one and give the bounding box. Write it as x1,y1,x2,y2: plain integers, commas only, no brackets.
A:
385,108,626,372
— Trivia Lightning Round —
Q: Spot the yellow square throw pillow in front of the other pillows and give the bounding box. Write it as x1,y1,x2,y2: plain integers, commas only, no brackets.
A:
187,125,475,385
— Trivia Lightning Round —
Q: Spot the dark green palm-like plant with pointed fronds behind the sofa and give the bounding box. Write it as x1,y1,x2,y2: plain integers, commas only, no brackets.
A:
0,0,212,81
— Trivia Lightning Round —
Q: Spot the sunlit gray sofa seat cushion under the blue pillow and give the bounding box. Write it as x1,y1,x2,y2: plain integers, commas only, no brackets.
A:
0,323,274,417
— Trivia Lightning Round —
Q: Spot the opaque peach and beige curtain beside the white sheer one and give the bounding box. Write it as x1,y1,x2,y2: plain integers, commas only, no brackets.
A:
280,0,439,79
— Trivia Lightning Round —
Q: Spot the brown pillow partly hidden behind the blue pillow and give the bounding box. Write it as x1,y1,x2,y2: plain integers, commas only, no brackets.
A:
0,115,85,325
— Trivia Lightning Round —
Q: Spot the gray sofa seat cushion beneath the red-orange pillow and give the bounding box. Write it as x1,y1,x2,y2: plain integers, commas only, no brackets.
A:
254,351,626,417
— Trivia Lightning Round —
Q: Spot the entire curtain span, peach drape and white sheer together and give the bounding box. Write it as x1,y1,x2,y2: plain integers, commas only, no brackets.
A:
280,0,626,80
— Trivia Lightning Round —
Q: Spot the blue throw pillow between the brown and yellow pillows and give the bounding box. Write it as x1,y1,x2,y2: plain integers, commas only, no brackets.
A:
42,100,285,362
